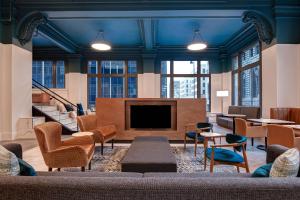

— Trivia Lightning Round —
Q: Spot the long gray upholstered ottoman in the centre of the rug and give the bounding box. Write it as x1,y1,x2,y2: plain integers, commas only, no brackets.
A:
121,136,177,173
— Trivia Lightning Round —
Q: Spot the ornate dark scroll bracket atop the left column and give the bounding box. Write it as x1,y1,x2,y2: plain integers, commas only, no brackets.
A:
16,12,47,46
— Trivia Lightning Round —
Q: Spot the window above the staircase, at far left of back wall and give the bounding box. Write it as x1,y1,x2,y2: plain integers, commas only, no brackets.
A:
32,60,65,88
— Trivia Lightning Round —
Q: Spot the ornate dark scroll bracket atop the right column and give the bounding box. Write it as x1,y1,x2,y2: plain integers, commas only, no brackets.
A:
243,11,274,44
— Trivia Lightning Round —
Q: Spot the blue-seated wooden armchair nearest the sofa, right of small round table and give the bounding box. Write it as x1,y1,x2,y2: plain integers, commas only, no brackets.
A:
204,134,250,173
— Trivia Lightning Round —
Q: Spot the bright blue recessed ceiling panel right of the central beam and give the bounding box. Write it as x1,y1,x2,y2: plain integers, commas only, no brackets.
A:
157,18,244,47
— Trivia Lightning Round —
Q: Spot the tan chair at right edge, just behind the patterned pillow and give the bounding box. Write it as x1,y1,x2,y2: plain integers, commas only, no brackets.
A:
267,125,300,150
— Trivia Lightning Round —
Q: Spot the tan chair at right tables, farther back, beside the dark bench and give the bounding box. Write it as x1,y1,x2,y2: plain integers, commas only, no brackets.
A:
235,118,267,146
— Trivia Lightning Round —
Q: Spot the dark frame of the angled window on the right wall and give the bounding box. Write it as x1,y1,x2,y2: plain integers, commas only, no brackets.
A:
231,41,262,107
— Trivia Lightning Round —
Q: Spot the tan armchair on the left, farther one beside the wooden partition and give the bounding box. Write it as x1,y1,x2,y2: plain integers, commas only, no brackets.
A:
77,115,117,155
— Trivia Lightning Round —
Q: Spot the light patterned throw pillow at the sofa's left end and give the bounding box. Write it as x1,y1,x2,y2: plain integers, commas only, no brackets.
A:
0,145,20,176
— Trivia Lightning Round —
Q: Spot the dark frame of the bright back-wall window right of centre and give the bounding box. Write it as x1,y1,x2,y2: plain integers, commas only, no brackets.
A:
159,59,211,112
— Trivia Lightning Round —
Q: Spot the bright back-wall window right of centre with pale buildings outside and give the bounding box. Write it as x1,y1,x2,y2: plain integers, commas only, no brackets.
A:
161,60,210,111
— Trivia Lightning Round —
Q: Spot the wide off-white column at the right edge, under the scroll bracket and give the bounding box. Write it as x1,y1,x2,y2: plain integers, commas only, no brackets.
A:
262,44,300,118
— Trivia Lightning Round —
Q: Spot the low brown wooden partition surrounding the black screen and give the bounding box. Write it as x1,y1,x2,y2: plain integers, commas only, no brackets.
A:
96,98,206,140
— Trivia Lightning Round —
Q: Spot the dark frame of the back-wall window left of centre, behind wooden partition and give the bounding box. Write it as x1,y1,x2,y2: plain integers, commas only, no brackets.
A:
86,59,139,102
